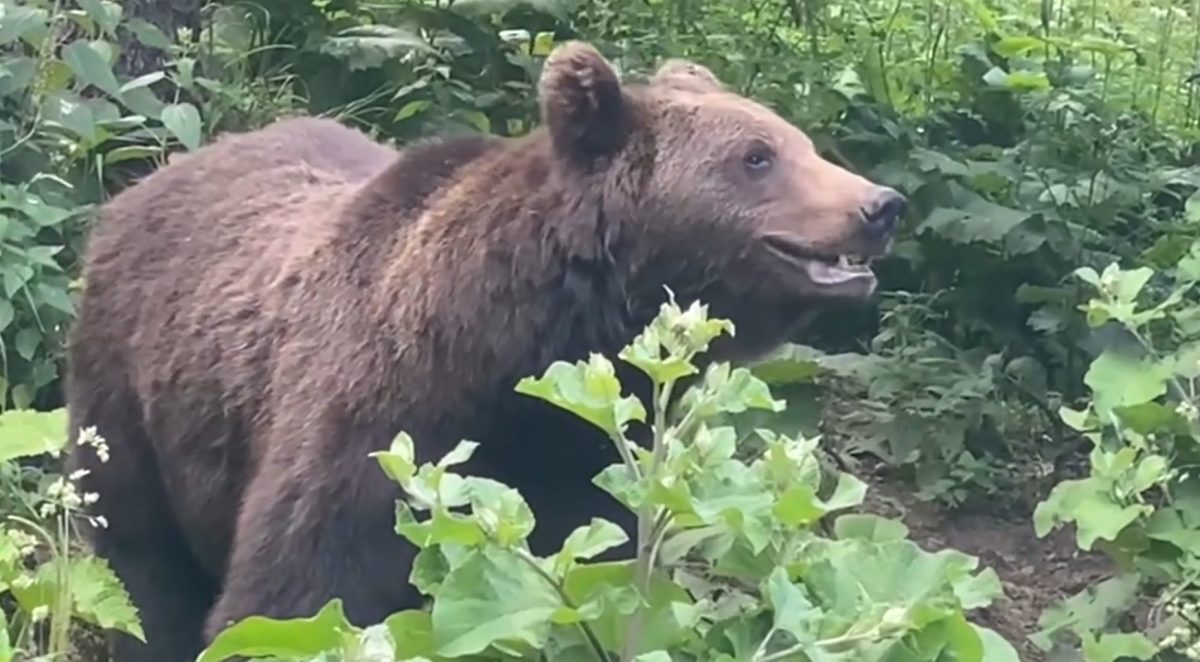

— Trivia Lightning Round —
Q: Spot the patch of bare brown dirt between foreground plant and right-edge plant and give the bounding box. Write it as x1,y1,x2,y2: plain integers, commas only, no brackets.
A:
859,462,1111,662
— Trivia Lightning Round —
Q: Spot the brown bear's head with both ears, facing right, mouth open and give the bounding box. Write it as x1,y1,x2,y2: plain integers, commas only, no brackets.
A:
540,42,905,353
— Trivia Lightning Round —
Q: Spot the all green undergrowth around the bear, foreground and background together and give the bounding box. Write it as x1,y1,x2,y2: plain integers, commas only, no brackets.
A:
0,0,1200,662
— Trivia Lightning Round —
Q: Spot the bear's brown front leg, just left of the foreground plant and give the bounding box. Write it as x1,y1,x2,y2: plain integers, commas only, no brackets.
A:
204,424,421,642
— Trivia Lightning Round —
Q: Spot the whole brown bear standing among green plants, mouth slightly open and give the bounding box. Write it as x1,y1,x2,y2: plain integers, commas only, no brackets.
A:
67,42,905,662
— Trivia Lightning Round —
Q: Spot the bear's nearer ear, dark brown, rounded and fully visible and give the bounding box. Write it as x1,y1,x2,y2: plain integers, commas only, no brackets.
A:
539,41,629,161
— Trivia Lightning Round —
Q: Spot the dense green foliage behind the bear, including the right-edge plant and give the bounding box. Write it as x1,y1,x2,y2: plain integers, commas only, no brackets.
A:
0,0,1200,655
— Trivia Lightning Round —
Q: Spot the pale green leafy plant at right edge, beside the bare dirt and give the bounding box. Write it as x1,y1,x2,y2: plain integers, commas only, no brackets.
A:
1033,251,1200,660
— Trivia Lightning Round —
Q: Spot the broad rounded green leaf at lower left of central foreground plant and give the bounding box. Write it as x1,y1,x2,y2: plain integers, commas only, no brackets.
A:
432,547,563,662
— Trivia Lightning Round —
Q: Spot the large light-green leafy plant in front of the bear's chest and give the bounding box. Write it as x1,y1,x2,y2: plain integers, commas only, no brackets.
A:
200,301,1016,662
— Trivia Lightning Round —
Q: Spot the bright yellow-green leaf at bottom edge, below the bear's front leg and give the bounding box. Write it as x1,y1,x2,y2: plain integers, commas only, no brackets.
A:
196,598,359,662
